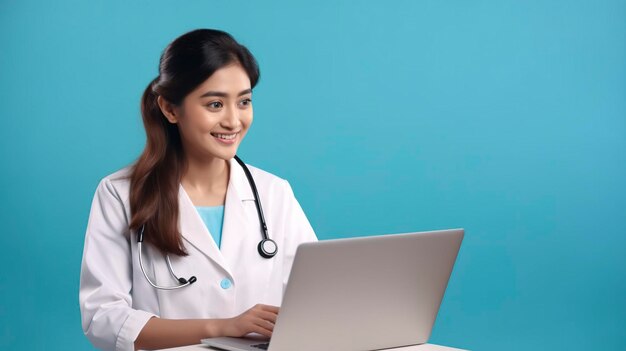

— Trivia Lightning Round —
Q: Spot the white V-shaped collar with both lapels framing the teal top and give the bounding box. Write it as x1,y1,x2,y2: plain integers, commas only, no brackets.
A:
178,159,254,279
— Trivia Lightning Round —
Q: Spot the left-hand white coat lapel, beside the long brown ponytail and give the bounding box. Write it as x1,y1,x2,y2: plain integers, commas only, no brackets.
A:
178,185,232,276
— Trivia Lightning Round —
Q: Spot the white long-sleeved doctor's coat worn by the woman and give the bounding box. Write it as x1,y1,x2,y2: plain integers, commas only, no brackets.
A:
79,159,317,350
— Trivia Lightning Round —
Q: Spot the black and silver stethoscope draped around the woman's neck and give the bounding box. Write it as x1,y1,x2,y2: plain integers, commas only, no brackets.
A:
137,156,278,290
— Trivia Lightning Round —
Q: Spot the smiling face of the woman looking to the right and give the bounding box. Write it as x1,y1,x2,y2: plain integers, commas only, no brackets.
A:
166,64,252,160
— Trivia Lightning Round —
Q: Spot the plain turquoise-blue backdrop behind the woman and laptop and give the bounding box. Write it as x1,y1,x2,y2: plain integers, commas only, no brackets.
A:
0,0,626,350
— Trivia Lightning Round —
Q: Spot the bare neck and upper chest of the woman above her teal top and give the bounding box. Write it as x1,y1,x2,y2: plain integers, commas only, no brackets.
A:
181,157,230,206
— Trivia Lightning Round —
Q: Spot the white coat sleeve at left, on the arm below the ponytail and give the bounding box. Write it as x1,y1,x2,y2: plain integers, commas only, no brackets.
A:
79,178,154,350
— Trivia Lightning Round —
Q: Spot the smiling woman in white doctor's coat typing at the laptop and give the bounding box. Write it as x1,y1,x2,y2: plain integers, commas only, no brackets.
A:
79,29,316,350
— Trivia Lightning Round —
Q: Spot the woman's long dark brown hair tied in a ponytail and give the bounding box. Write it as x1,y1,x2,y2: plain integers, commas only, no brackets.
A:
130,29,260,256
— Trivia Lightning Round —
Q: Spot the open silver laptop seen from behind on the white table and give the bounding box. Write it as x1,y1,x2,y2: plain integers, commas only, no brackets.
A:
202,229,464,351
